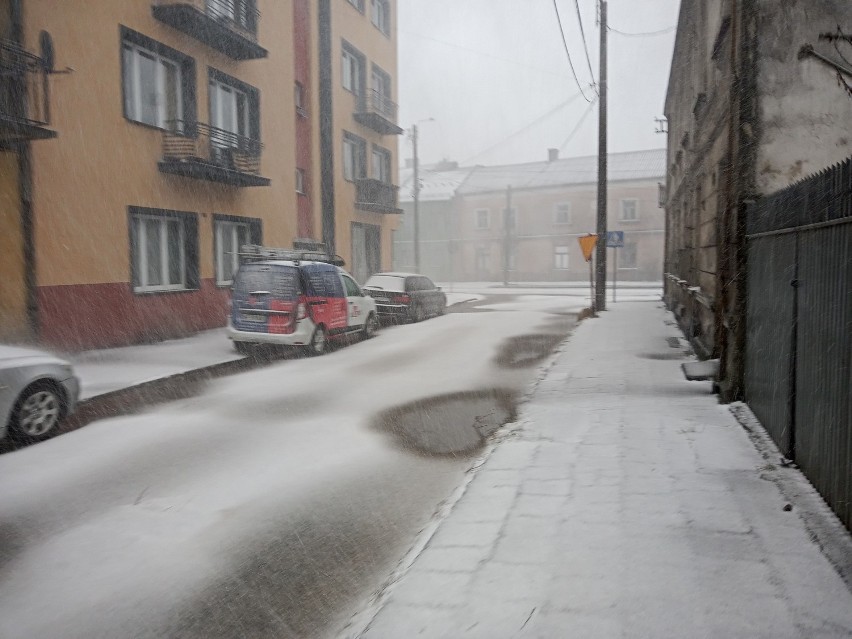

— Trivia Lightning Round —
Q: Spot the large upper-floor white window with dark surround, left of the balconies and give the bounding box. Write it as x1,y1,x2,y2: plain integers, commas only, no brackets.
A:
121,28,195,130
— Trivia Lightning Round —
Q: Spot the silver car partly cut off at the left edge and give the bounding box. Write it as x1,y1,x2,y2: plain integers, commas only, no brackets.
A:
0,344,80,443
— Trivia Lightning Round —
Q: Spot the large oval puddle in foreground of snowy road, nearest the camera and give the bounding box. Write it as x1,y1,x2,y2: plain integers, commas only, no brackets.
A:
374,388,518,455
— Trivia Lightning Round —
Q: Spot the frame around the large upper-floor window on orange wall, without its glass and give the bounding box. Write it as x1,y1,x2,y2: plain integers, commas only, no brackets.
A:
119,25,196,132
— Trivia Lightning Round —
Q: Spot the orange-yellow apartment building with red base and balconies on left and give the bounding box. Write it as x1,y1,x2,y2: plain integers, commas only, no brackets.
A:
0,0,396,349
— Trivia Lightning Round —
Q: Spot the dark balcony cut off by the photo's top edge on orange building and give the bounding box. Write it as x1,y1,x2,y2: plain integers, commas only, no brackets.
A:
151,0,267,60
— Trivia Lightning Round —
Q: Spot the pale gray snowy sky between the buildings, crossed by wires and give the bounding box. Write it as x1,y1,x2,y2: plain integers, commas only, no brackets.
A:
398,0,679,164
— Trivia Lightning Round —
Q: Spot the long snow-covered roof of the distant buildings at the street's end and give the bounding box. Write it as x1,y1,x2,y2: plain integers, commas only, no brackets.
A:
399,149,666,202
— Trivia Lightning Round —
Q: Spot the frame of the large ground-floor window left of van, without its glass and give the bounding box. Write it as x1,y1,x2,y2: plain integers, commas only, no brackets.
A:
128,206,200,295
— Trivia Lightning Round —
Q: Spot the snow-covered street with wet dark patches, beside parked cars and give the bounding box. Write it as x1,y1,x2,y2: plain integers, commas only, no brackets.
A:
0,295,582,639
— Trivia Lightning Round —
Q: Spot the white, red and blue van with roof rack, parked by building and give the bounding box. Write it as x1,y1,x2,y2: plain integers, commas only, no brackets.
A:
227,247,378,355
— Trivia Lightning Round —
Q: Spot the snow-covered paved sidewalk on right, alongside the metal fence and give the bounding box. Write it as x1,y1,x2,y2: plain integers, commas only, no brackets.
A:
352,302,852,639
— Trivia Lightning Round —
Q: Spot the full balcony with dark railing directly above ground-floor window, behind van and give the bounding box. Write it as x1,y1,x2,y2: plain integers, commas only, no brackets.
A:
157,122,269,187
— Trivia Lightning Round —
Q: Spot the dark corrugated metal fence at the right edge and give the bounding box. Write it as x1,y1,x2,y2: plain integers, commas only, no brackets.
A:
745,158,852,530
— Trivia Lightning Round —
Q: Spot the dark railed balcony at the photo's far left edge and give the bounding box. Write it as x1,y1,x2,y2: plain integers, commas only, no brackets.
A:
0,39,56,143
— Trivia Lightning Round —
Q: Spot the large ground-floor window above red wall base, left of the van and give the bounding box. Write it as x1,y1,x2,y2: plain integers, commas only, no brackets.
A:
130,207,198,293
